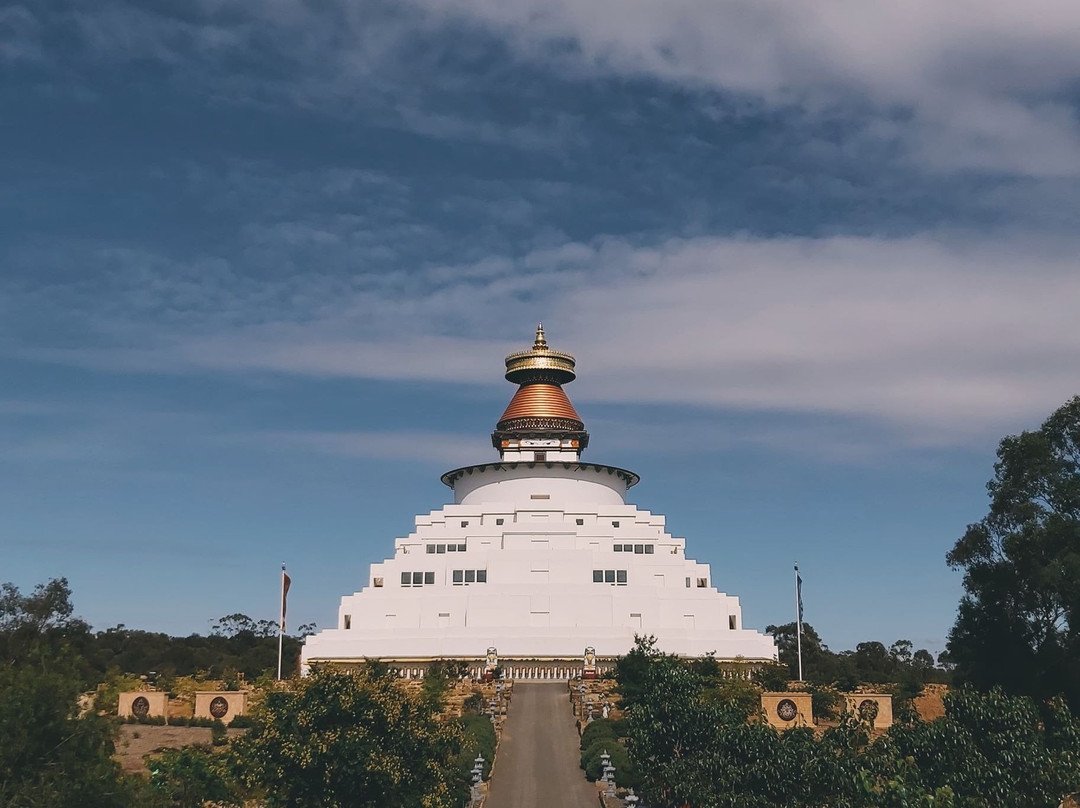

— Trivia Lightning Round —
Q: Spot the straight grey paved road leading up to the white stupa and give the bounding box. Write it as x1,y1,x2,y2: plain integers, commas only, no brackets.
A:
485,682,597,808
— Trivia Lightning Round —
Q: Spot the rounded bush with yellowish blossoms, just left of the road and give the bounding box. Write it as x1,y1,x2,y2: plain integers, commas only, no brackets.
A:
231,670,462,808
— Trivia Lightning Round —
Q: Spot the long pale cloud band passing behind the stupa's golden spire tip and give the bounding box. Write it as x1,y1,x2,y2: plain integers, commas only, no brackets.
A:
15,230,1080,442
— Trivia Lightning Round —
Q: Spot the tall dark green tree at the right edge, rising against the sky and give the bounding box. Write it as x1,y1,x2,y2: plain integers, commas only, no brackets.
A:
947,396,1080,709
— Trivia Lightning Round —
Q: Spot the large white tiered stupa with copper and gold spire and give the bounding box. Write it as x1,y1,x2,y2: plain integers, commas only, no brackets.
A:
301,326,777,678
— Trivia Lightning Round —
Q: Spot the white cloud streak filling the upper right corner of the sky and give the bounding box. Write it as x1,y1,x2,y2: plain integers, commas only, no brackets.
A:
421,0,1080,177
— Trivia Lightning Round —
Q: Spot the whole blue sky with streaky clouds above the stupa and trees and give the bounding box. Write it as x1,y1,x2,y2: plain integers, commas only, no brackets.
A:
0,0,1080,651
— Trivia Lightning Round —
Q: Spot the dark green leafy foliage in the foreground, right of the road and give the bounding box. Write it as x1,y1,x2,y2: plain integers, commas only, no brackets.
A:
627,643,1080,808
